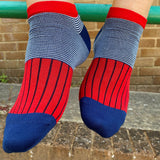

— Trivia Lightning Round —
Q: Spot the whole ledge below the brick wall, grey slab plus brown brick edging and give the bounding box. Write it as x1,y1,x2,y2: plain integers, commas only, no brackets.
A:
0,83,160,160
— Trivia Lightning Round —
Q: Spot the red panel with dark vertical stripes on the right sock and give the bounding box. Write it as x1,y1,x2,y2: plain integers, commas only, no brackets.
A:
79,58,132,112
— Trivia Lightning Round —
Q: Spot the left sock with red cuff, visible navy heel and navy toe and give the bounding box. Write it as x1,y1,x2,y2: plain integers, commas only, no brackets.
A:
3,1,90,153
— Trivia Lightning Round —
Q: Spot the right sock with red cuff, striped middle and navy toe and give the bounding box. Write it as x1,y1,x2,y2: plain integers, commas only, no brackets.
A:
79,7,146,138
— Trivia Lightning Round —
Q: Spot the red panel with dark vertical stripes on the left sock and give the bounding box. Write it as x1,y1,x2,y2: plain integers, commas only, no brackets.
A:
10,58,73,121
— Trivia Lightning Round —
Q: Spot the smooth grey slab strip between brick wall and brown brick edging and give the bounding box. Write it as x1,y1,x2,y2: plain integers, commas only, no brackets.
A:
0,83,160,131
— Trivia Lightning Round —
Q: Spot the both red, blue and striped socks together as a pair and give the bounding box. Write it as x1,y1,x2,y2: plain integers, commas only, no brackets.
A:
3,1,146,153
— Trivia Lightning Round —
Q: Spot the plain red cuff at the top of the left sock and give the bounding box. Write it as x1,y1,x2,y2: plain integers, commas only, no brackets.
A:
27,1,78,18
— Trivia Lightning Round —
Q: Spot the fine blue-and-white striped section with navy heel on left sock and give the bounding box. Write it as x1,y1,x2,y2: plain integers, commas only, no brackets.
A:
25,12,90,69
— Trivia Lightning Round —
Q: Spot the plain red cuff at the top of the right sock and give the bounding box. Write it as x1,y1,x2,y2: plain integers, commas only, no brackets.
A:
107,7,147,28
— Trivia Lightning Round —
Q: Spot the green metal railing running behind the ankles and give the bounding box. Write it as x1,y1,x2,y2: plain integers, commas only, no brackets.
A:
0,1,160,24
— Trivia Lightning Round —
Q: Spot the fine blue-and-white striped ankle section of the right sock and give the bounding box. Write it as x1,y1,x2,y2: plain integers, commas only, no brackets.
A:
94,18,143,68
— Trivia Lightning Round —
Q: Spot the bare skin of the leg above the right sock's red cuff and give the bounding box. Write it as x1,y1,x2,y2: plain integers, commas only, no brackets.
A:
113,0,153,18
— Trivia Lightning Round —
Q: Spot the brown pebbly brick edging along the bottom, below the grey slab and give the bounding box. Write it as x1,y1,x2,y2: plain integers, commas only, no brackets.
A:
0,121,160,160
